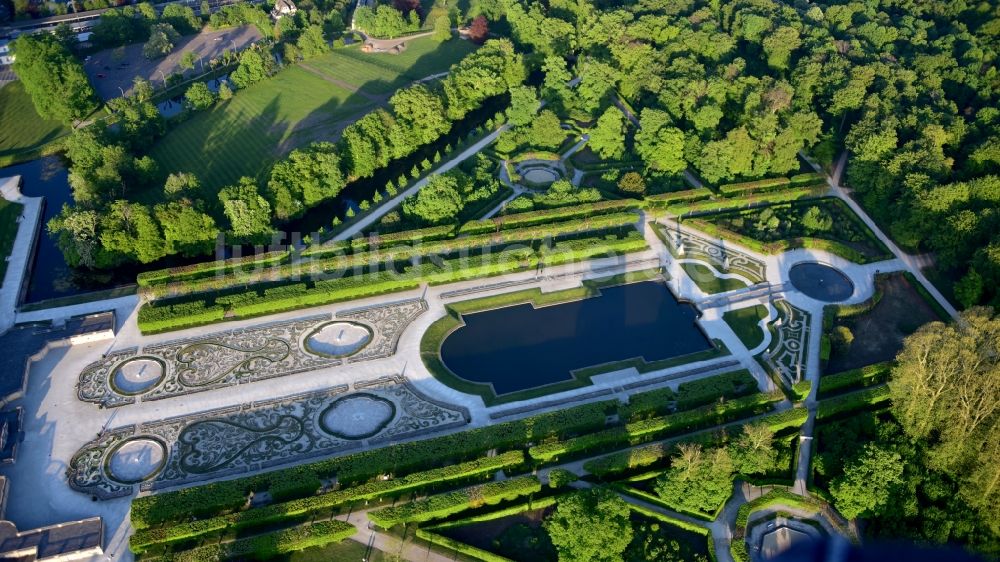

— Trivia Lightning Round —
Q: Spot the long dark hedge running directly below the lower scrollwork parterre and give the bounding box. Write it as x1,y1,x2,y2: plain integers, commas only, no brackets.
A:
132,400,618,529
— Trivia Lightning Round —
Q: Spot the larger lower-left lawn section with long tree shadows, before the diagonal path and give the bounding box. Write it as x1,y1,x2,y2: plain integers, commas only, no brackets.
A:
144,67,371,192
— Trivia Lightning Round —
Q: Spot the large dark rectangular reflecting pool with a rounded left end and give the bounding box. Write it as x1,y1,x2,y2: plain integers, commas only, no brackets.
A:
441,281,712,394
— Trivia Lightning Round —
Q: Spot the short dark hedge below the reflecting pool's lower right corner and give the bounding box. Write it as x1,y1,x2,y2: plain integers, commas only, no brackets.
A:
618,369,757,421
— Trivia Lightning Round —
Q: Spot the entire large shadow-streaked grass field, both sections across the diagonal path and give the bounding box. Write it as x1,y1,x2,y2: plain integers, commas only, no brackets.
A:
146,37,474,196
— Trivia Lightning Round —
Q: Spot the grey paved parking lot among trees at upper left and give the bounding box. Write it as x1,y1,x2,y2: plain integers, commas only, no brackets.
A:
83,25,261,101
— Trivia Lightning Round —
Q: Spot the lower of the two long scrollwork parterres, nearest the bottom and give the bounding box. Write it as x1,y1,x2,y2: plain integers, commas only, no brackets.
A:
68,376,470,499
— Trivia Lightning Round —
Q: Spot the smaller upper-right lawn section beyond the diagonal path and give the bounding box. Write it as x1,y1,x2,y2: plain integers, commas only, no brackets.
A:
306,37,476,94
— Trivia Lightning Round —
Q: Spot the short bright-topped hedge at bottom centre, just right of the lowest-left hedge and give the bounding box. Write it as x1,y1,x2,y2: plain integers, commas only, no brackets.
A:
368,476,542,529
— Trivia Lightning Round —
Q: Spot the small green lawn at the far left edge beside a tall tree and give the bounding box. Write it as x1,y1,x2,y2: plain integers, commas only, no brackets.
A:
0,81,69,166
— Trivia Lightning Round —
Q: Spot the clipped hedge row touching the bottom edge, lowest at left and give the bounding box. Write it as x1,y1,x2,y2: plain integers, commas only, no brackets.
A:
174,520,357,562
